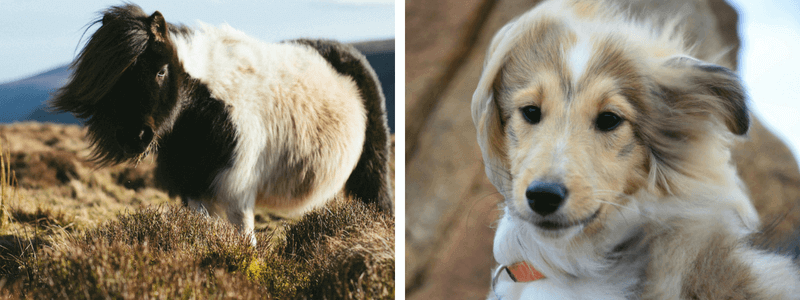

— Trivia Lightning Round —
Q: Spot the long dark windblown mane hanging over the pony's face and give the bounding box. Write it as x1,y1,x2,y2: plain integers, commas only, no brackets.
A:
49,4,191,166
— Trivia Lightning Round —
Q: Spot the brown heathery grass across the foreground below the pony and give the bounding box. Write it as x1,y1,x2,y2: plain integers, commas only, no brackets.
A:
0,200,394,299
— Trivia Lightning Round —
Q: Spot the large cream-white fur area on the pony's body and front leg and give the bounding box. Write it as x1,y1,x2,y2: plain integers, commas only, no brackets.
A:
172,24,366,237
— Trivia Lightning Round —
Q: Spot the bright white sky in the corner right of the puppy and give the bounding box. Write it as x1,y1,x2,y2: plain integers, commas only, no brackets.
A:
728,0,800,159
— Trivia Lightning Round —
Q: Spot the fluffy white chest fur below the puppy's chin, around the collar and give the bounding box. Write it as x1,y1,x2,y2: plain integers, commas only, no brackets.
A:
493,202,644,299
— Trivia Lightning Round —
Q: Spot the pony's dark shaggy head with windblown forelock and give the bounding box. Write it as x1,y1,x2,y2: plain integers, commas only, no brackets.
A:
51,4,183,165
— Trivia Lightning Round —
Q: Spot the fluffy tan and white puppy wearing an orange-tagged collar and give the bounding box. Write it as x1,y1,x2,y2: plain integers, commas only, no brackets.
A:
472,0,800,299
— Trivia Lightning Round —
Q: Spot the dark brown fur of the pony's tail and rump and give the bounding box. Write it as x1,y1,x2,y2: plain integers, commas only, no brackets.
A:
289,39,394,214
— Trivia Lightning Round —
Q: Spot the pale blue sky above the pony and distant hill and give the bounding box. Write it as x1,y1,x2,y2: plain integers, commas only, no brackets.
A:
0,0,395,84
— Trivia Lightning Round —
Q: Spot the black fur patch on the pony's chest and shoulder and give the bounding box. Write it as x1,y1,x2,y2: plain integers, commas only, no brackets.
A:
155,82,237,201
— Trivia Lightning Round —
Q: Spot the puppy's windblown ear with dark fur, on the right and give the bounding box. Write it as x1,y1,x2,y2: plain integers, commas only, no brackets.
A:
656,56,750,135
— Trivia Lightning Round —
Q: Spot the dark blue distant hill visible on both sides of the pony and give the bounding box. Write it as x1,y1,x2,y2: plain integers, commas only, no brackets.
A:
0,39,395,133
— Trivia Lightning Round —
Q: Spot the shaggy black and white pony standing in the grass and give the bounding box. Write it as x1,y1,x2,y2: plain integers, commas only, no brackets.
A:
51,4,393,243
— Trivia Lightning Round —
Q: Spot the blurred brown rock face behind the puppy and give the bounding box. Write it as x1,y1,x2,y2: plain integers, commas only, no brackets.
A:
405,0,800,299
